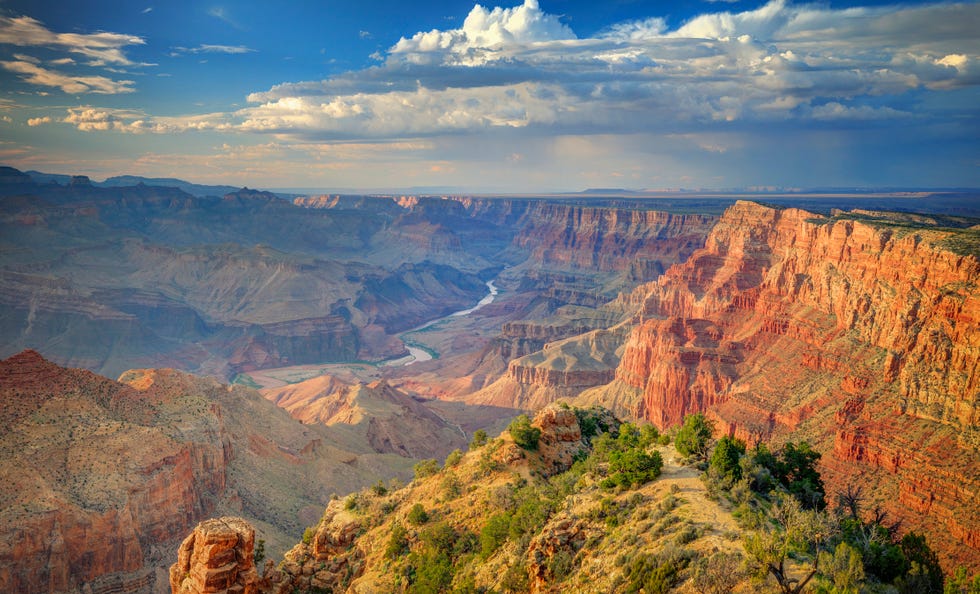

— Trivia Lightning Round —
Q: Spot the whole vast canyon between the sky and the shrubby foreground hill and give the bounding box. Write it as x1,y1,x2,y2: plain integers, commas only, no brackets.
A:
0,168,980,592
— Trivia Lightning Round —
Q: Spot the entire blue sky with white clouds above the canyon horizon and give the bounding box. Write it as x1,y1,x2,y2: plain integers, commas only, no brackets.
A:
0,0,980,193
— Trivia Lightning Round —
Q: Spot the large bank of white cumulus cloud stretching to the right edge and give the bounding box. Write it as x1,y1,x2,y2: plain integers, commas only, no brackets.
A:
63,0,980,142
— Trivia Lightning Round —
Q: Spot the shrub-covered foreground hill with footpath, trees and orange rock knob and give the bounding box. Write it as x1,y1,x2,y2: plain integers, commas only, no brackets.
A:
170,405,964,594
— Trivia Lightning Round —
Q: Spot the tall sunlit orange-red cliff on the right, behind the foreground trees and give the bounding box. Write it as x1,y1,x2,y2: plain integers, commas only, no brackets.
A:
600,202,980,571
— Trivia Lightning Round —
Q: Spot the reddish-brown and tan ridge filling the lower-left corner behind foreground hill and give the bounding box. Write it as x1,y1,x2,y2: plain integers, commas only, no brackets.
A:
0,351,456,594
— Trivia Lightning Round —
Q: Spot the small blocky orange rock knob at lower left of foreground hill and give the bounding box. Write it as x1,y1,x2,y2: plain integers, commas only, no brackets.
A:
170,517,259,594
